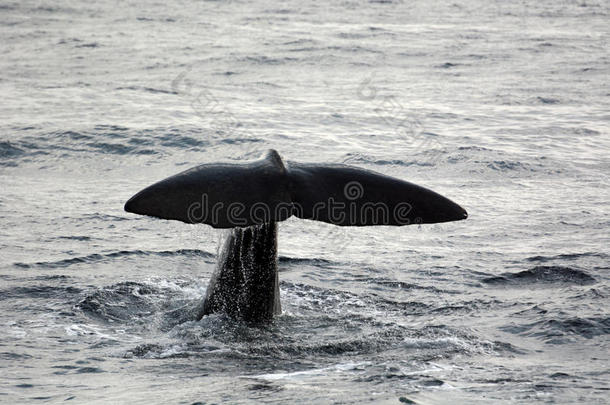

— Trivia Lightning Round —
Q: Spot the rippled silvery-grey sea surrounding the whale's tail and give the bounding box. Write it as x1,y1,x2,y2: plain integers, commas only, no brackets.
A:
0,0,610,404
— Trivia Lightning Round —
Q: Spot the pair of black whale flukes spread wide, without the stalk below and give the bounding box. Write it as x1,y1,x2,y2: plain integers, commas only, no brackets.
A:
125,149,468,228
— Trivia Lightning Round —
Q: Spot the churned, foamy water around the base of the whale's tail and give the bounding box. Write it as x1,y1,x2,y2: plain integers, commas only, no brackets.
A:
77,282,504,363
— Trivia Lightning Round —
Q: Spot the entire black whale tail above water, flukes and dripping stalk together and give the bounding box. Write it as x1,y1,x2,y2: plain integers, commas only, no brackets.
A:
125,149,468,322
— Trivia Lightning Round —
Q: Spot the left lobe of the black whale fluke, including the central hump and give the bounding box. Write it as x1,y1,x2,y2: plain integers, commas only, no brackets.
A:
125,150,292,228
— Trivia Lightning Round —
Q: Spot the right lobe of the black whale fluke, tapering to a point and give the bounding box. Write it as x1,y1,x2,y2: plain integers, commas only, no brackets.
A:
289,162,468,226
